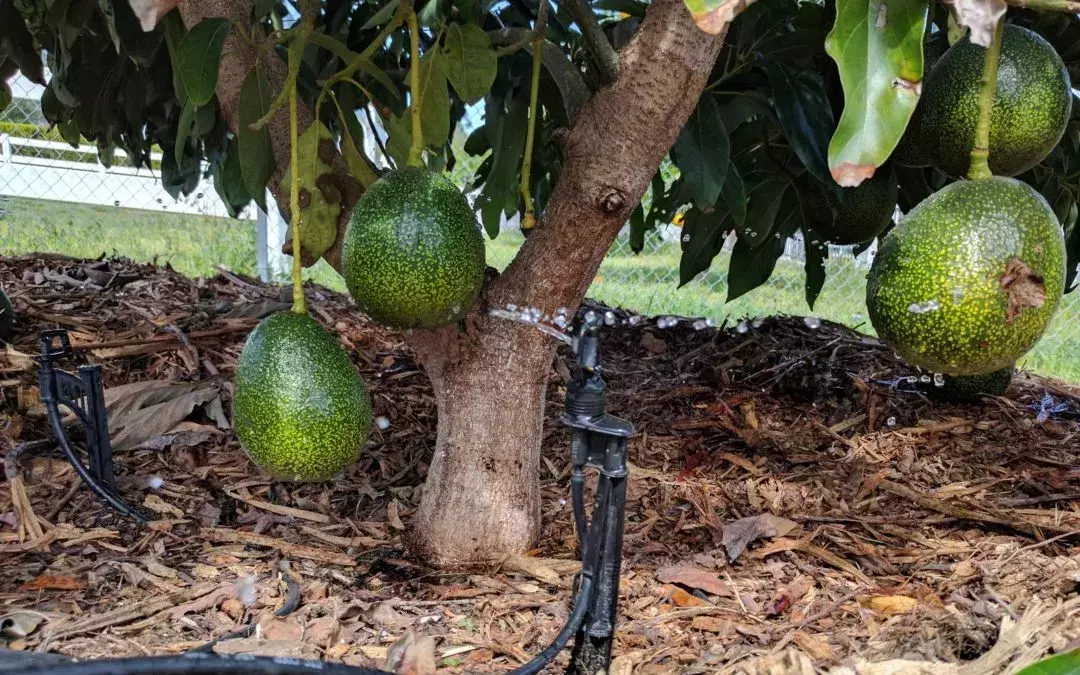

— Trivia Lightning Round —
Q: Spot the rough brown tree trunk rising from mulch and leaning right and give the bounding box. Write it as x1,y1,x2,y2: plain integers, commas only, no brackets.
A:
180,0,724,566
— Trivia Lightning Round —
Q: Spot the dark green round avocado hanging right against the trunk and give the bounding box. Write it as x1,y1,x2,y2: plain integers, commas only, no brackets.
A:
341,167,486,328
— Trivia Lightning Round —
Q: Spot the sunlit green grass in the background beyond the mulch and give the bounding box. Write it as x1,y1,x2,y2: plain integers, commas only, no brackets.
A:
0,199,1080,382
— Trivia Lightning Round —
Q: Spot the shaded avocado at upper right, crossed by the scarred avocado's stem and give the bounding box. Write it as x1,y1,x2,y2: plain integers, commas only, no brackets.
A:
912,24,1072,177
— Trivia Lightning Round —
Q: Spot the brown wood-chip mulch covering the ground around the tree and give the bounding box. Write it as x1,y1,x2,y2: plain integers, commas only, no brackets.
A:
0,255,1080,675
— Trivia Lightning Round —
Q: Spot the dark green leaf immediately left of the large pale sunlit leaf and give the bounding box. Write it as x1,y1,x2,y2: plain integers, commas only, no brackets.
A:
765,59,833,185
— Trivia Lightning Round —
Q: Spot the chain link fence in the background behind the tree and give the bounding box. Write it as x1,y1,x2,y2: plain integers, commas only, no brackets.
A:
0,73,1080,382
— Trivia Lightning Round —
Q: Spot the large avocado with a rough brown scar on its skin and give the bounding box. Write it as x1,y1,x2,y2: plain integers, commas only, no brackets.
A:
866,176,1065,375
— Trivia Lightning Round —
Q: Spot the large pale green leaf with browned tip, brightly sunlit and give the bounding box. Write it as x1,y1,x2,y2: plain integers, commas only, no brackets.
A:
825,0,928,187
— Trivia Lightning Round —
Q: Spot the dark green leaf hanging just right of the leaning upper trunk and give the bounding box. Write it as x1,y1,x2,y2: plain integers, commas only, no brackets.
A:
672,96,731,208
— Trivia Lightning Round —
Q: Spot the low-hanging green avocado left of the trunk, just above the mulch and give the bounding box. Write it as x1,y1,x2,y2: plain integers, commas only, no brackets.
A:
232,311,372,481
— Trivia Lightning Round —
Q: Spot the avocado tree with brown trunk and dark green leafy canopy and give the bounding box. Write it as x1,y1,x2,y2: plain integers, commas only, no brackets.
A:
0,0,1080,565
